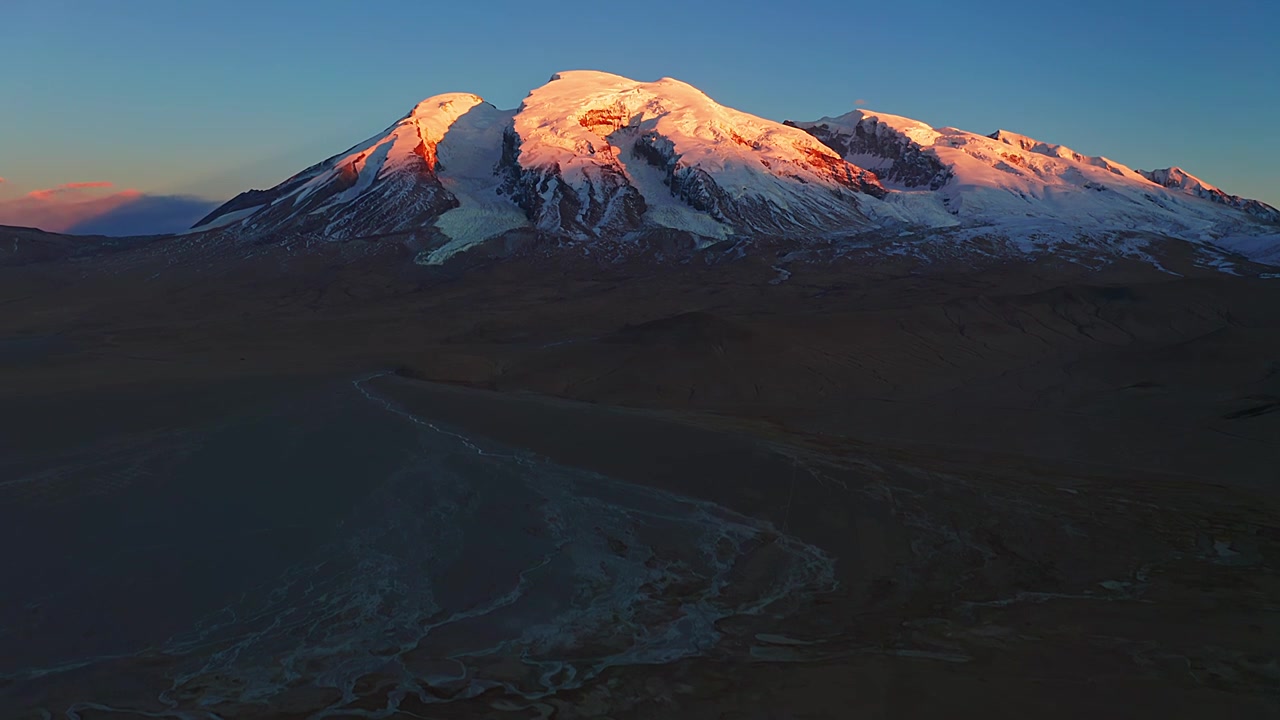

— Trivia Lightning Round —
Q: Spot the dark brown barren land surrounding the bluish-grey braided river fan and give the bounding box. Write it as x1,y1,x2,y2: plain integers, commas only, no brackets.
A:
0,230,1280,719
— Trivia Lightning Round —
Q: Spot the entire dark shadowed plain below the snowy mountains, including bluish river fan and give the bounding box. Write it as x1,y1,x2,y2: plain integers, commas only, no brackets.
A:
0,233,1280,719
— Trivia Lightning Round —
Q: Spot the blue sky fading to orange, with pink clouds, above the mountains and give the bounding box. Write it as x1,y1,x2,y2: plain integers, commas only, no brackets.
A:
0,0,1280,217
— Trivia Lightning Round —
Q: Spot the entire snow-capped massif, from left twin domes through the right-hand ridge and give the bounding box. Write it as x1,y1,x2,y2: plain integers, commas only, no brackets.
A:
192,70,1280,263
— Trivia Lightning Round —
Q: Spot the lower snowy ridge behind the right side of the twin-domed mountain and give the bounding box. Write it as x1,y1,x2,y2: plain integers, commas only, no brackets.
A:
788,110,1280,241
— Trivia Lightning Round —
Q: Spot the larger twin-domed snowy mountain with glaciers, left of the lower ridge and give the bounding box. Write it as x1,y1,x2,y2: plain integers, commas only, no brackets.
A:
195,72,886,259
